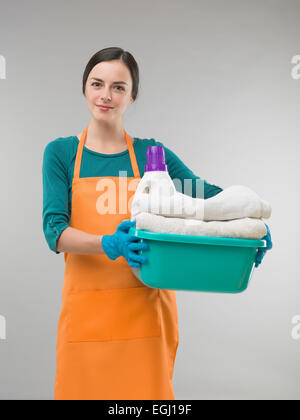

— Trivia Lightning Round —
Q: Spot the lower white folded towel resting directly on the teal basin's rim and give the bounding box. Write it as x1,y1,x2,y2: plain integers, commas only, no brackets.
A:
136,212,267,239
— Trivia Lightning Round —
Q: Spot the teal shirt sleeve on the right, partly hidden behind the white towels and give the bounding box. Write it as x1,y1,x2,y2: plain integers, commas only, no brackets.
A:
156,142,223,199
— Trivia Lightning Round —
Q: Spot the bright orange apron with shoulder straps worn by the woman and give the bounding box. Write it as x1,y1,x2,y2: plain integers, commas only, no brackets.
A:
54,127,179,400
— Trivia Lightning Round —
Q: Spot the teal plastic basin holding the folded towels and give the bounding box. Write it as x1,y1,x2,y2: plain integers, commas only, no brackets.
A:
129,227,266,293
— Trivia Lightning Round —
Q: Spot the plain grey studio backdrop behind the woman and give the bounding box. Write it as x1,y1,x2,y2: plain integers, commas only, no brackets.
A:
0,0,300,399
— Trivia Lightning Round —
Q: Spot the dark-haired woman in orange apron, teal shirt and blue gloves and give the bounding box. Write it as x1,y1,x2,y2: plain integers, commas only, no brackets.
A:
43,48,222,400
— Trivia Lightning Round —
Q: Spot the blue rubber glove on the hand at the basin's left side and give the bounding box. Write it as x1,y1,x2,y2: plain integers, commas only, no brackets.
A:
102,220,149,267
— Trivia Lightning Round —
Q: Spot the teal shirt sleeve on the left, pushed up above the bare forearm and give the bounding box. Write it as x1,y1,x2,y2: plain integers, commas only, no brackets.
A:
42,139,70,254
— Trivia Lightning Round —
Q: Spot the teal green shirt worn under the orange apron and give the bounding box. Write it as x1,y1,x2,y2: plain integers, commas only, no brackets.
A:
42,136,223,254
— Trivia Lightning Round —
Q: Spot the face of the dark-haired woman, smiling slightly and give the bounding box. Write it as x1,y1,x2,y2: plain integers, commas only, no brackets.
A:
85,60,133,122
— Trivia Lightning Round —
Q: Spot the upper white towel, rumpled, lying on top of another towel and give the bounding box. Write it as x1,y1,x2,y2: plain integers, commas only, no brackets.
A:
131,185,271,221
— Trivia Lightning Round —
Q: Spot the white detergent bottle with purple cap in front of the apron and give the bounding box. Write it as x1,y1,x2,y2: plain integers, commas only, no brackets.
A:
131,146,177,221
